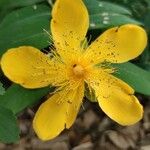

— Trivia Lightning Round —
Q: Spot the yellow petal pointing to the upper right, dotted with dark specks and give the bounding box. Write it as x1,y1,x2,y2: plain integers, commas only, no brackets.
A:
85,24,147,64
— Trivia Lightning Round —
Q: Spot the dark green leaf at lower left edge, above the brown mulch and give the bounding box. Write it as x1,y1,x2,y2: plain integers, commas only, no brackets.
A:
0,106,19,143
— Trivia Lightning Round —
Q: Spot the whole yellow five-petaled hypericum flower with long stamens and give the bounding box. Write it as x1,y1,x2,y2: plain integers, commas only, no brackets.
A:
1,0,147,140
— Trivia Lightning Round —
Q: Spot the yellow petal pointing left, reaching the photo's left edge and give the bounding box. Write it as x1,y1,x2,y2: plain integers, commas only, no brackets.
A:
1,46,67,88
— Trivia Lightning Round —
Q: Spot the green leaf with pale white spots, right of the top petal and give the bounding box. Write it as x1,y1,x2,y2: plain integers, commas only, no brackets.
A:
85,0,142,29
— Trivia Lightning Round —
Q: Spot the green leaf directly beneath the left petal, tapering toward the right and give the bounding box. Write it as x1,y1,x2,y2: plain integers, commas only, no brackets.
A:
0,84,52,114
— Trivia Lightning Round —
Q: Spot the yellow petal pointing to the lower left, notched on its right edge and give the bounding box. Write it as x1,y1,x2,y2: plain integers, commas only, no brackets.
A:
33,84,84,140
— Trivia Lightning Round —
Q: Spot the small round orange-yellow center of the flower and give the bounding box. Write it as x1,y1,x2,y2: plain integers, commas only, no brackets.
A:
73,64,84,78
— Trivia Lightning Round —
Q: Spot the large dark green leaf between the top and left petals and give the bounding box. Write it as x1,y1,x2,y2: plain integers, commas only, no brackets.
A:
0,5,50,55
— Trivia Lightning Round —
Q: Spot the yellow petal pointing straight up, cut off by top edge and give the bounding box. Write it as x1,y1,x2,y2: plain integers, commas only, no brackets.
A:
51,0,89,61
